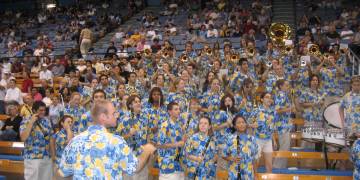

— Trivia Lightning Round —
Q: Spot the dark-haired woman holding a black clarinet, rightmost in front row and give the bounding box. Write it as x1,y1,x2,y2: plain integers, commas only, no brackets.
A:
223,116,259,180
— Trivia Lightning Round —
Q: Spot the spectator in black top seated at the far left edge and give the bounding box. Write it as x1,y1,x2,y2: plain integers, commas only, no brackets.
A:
0,102,22,141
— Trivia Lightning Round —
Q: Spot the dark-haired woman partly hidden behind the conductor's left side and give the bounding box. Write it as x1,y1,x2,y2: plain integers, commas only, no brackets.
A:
50,115,74,179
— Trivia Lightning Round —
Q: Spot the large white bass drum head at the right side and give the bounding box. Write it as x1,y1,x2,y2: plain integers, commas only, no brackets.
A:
323,102,342,128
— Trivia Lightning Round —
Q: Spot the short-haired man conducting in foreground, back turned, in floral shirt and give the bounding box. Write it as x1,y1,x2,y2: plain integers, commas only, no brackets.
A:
58,100,156,179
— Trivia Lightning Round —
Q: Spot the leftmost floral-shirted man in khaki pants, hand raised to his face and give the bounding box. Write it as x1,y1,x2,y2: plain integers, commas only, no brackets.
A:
20,101,53,180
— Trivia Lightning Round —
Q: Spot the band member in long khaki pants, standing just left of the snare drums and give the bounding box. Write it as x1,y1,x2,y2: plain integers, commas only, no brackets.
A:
274,79,295,168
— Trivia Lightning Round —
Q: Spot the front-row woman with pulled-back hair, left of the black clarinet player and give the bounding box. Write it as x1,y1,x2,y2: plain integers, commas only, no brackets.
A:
184,117,216,179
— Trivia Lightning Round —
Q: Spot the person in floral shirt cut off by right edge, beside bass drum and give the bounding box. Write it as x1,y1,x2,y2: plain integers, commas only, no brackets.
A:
339,75,360,134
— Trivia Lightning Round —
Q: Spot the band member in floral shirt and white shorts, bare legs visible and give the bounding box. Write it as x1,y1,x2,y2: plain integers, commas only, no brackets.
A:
249,92,276,173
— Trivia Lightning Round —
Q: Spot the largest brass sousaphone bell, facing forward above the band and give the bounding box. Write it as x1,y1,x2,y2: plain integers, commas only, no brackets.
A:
269,23,292,47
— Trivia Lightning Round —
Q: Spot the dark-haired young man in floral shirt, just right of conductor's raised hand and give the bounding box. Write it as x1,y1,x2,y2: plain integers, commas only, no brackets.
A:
157,102,184,180
